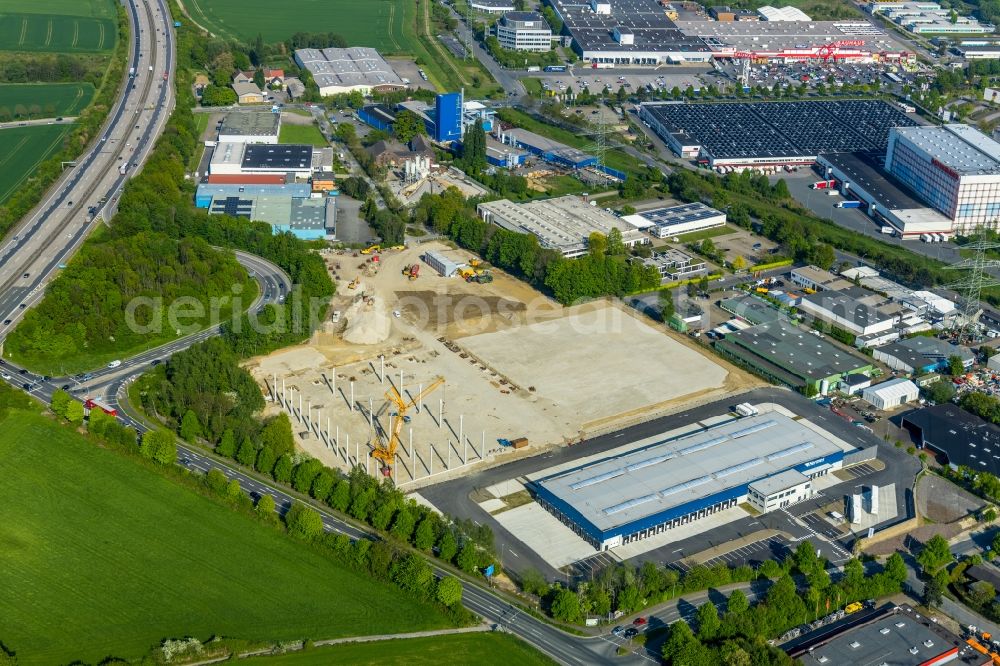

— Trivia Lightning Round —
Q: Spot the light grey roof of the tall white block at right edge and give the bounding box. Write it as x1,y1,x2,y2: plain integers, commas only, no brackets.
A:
893,125,1000,176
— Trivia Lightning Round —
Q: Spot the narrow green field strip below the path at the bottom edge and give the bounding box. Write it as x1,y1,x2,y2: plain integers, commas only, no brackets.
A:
239,633,555,666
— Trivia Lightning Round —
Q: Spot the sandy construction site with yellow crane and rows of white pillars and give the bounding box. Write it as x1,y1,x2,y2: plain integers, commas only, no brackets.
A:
248,241,762,489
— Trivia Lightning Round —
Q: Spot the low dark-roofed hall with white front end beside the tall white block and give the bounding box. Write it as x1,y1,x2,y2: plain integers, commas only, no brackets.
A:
816,153,953,239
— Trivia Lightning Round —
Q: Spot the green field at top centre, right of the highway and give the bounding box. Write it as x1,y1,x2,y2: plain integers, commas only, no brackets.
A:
184,0,413,53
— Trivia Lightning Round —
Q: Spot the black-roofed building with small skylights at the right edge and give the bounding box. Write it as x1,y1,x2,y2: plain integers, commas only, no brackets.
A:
902,402,1000,476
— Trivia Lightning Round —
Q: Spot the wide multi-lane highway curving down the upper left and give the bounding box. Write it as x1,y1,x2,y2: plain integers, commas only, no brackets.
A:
0,0,175,343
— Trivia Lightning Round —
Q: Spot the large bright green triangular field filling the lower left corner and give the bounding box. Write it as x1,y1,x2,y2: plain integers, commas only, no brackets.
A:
0,412,448,666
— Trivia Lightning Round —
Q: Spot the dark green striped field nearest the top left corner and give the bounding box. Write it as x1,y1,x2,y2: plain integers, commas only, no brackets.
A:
0,13,117,53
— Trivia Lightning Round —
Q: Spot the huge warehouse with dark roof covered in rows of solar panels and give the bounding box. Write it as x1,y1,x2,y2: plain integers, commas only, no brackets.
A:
639,100,916,167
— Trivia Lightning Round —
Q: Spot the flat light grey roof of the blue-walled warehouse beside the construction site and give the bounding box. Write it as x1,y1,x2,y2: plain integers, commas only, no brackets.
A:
536,412,843,532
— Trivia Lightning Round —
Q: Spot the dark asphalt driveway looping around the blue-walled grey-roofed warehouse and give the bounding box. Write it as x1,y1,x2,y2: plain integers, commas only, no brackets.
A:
419,388,920,580
